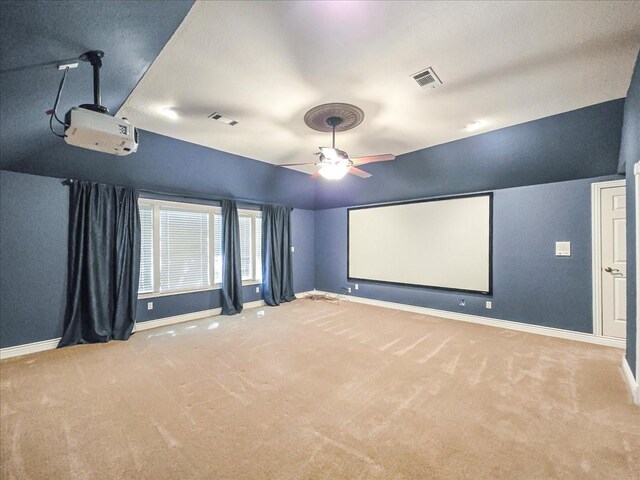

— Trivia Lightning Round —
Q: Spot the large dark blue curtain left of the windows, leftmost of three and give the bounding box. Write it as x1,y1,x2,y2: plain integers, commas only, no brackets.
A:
58,181,140,347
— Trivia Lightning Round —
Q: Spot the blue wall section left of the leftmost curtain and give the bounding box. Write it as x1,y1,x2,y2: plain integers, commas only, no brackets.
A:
0,171,69,347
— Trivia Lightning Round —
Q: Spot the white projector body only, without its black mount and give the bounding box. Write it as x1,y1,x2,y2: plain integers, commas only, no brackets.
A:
64,107,138,155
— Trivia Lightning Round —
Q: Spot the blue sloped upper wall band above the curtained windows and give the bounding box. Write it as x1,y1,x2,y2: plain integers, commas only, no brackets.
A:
0,126,314,209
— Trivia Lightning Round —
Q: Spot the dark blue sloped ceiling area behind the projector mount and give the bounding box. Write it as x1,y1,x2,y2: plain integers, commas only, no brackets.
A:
0,0,193,173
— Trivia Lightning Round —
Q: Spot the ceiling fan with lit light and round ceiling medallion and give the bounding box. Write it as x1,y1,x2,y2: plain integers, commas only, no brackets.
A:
281,103,396,180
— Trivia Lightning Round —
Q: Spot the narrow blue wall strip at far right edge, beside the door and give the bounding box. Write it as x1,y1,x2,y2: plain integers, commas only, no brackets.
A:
620,49,640,378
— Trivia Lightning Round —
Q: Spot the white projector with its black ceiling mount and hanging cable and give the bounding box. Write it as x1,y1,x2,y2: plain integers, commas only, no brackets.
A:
50,50,138,155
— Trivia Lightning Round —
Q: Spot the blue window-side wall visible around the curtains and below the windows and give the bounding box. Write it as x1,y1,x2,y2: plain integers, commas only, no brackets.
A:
0,171,314,348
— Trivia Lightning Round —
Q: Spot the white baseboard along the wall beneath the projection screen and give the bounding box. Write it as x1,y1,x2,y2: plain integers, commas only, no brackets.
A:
315,291,626,349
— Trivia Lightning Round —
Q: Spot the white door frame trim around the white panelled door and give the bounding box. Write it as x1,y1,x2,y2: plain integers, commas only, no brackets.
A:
591,179,629,337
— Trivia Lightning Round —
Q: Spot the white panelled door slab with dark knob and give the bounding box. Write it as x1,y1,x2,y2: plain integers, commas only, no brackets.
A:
600,187,627,338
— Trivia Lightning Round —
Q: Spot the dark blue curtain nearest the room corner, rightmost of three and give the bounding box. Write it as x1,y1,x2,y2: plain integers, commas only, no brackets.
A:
262,205,296,305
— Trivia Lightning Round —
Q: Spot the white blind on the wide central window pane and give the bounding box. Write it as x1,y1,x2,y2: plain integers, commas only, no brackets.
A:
160,207,210,292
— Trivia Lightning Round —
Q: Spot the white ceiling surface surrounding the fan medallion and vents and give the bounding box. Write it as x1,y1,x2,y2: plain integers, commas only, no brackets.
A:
118,1,640,171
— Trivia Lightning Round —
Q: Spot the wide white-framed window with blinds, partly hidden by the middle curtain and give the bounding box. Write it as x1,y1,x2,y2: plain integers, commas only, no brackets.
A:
138,199,262,296
